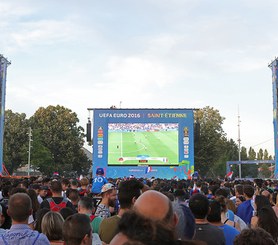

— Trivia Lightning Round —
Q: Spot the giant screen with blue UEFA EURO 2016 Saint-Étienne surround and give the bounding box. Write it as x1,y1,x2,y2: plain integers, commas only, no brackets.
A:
93,109,194,179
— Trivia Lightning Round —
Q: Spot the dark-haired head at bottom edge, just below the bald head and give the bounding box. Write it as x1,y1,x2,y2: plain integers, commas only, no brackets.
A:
110,211,175,245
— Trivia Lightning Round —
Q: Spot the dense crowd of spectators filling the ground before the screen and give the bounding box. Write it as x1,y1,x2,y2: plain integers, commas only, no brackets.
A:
0,169,278,245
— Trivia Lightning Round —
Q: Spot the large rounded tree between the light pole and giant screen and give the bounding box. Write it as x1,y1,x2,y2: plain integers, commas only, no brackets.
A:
31,105,90,174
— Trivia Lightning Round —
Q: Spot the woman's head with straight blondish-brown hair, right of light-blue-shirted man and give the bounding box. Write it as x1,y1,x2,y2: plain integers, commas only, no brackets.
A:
41,211,64,241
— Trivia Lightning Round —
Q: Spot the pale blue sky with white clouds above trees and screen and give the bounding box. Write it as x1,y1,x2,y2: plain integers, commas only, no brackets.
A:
0,0,278,154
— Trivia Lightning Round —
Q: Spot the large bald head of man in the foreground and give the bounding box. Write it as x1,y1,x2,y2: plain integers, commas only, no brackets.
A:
134,190,178,226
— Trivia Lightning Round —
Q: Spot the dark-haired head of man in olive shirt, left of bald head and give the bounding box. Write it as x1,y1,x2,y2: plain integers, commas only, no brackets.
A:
118,179,144,209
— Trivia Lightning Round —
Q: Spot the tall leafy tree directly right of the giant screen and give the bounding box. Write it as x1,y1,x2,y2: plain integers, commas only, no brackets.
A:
194,106,227,176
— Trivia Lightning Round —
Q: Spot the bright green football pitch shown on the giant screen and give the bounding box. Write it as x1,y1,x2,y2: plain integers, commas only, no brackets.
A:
108,129,178,166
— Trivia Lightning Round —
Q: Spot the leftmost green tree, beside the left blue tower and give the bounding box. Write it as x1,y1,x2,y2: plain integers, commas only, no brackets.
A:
3,110,29,173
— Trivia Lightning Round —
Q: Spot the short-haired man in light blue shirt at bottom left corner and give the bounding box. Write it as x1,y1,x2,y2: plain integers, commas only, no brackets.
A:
0,193,50,245
